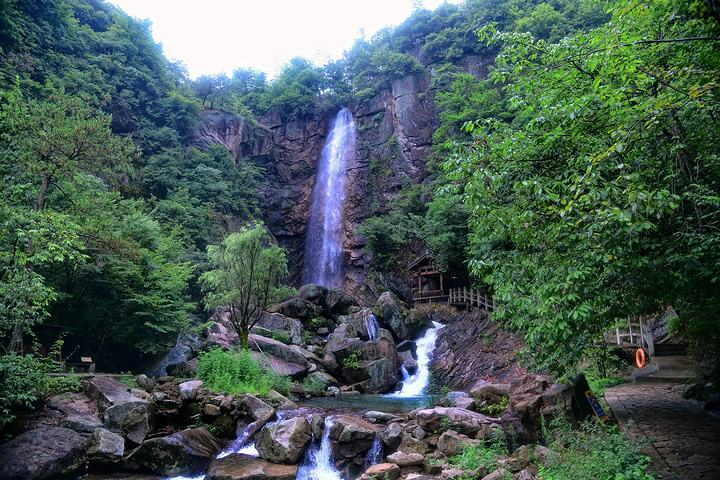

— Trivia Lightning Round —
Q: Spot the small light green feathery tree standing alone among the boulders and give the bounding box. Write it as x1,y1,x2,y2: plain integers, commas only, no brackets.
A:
200,225,289,348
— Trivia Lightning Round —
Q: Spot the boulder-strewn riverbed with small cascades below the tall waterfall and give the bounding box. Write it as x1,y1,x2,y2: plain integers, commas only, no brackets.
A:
0,285,584,480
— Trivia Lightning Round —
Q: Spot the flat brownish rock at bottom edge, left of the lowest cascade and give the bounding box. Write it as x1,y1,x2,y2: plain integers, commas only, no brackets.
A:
205,454,297,480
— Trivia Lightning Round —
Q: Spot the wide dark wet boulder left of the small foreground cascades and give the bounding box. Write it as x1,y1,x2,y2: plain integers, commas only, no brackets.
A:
127,428,221,476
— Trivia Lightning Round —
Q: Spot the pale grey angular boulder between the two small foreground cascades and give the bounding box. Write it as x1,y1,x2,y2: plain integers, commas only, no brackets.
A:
255,417,312,464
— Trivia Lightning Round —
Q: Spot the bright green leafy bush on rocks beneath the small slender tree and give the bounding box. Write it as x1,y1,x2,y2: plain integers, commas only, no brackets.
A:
198,348,291,395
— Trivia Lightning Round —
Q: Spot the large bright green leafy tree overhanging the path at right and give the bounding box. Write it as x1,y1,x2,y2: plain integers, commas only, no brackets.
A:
445,0,720,374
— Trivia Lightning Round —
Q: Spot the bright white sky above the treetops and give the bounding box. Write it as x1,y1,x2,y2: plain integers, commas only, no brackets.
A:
110,0,459,78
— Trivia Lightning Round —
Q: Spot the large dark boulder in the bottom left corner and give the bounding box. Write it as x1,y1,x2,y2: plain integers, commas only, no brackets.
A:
0,427,85,480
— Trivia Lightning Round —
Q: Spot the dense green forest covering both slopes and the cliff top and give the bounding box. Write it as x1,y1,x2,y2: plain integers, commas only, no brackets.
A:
0,0,720,412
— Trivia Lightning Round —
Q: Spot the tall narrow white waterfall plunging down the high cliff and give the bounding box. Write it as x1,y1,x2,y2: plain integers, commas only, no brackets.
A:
304,108,355,288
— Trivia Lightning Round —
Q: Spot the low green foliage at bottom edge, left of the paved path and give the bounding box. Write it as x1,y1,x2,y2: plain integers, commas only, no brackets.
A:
539,422,653,480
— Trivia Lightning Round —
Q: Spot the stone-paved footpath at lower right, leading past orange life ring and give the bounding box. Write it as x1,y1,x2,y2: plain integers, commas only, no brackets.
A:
605,382,720,480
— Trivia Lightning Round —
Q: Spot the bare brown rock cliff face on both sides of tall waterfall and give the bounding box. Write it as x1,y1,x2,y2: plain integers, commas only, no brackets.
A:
199,72,437,296
